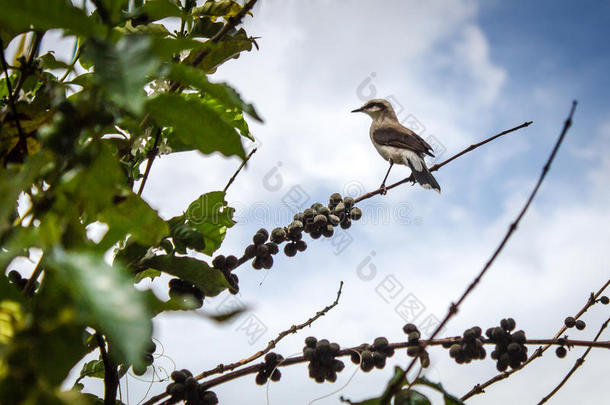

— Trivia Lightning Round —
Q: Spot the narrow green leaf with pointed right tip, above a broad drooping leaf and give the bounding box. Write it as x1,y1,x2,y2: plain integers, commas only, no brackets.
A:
169,63,263,122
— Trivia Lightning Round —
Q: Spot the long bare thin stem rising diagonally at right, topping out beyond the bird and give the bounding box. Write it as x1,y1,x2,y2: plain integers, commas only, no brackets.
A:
394,100,577,394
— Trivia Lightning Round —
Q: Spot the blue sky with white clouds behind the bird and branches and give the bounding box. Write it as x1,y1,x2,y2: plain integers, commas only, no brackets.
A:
65,0,610,404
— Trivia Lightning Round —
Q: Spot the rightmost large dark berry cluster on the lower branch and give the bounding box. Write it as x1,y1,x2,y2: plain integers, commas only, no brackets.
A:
485,318,527,372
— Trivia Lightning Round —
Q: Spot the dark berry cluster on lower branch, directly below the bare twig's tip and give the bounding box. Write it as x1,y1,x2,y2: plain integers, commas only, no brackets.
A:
303,336,345,383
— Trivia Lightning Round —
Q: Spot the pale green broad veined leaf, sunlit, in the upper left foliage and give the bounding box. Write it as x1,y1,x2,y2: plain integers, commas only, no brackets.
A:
84,35,161,115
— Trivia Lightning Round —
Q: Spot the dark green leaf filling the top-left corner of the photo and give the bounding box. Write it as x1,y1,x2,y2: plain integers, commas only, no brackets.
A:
0,0,105,37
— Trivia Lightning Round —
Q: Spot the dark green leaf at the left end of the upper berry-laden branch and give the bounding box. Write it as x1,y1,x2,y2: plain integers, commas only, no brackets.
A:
142,255,229,297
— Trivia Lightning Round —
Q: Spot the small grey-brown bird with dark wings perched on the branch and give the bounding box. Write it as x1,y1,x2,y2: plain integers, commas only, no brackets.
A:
352,98,441,194
